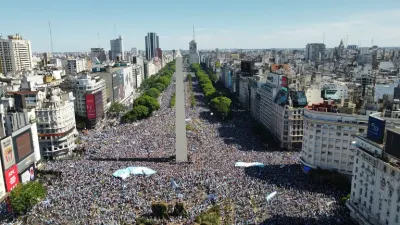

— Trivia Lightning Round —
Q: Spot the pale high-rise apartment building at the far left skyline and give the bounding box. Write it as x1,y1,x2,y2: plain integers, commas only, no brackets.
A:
0,34,33,74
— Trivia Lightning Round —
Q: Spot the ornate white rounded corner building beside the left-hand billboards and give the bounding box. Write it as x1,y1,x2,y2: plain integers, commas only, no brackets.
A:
36,88,78,158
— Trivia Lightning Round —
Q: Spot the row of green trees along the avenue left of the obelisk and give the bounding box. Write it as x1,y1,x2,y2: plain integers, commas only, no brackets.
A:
121,61,175,123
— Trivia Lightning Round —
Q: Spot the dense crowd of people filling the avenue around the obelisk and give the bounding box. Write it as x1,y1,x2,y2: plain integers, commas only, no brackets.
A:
20,73,351,225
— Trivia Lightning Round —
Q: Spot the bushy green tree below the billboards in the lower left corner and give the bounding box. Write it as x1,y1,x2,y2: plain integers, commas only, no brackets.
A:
10,181,47,215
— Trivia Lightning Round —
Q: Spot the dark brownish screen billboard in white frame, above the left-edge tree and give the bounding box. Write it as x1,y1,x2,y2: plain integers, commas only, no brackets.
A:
12,126,34,163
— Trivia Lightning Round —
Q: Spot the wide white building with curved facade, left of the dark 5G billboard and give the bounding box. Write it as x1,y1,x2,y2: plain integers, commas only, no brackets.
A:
300,104,368,175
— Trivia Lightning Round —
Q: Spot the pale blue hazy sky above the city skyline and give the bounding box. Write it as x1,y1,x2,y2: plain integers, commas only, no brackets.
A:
0,0,400,52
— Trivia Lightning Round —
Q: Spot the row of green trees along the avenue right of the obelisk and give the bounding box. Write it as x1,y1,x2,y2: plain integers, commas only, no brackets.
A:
191,64,232,119
